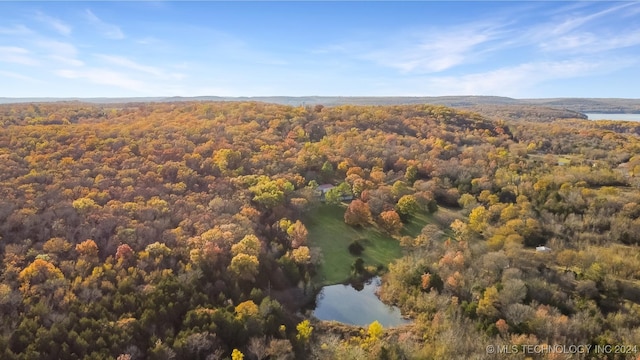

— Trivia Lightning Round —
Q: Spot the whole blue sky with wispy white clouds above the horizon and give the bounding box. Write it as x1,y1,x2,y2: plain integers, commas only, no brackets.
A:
0,1,640,98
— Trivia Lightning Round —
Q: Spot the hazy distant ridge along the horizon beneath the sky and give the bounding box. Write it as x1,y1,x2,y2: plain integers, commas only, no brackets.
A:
0,96,640,113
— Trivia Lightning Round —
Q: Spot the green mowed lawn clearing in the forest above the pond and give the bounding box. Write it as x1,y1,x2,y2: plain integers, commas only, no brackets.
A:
304,205,402,285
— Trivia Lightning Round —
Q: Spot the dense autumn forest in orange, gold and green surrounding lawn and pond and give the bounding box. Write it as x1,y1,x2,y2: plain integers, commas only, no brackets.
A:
0,102,640,360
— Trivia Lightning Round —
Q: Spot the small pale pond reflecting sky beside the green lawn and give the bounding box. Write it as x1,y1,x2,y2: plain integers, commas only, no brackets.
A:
313,277,411,327
